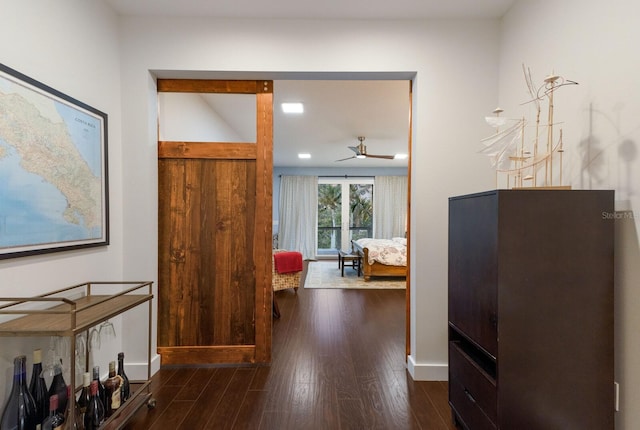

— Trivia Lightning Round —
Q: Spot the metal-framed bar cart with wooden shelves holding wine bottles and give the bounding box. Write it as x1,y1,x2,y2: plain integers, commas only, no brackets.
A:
0,281,156,430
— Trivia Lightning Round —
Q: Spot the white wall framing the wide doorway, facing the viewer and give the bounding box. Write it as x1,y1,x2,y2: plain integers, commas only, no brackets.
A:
121,18,498,379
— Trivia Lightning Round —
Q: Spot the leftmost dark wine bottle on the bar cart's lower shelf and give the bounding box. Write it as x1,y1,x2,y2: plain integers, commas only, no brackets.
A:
0,355,38,430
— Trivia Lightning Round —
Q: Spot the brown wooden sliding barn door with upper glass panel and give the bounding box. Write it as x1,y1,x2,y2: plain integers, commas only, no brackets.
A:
158,79,273,364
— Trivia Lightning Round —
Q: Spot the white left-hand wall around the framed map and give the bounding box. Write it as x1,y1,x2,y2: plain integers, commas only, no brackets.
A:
0,0,123,407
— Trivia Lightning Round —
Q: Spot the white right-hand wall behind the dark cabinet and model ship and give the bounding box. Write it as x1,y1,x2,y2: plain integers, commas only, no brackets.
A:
499,0,640,429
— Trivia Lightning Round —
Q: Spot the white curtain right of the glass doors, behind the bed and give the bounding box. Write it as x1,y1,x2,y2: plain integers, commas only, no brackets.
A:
373,176,408,239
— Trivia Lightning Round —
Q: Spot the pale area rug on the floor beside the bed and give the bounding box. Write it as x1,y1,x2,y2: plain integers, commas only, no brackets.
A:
304,261,407,289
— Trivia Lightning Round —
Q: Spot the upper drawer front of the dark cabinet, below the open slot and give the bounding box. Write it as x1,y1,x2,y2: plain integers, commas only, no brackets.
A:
449,342,497,423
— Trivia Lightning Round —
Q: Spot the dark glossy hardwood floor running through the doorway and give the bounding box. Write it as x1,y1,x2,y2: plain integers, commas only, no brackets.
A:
125,278,455,430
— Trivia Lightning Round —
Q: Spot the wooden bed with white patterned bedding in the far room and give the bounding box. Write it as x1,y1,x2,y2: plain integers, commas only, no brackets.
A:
351,237,407,282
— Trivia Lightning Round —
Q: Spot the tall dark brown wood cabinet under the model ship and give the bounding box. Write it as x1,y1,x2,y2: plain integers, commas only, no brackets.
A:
448,189,614,430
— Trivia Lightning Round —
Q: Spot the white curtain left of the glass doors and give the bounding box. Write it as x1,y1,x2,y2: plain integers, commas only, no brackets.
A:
278,176,318,260
